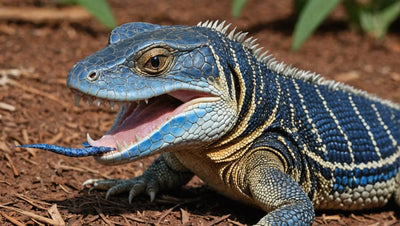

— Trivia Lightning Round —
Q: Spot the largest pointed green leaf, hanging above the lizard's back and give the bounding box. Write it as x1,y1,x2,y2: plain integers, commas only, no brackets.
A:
292,0,340,51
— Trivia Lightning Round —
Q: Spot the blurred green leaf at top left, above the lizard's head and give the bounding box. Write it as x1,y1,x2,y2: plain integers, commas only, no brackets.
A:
76,0,117,29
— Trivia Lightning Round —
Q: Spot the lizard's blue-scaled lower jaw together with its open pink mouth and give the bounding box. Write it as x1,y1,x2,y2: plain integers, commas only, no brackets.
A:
72,90,220,164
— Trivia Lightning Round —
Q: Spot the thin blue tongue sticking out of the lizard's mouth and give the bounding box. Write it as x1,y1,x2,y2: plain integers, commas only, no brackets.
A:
15,142,115,157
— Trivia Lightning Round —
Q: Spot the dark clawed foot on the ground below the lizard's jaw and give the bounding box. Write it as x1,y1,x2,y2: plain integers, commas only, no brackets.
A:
83,175,159,204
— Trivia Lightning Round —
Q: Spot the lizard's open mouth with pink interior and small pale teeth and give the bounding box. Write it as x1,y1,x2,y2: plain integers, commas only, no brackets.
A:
76,90,212,156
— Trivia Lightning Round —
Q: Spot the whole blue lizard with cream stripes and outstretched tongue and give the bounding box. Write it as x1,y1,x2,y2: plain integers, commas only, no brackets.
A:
21,21,400,225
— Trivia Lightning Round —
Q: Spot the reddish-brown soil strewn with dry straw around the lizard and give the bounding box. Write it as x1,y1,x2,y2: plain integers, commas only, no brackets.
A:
0,0,400,225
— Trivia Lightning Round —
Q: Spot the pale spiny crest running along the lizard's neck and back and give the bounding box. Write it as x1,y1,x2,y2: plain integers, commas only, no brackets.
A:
197,20,400,109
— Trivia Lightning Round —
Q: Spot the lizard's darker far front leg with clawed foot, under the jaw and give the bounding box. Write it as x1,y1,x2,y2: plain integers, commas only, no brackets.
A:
83,152,193,203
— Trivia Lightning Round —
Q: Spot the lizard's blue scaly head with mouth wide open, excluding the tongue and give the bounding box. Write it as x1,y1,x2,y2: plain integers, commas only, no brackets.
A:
67,23,242,164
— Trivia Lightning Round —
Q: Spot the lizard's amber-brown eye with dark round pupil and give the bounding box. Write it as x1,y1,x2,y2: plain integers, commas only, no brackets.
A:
136,47,173,76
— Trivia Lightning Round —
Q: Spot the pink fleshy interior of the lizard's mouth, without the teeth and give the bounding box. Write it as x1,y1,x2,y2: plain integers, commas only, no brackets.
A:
90,91,209,148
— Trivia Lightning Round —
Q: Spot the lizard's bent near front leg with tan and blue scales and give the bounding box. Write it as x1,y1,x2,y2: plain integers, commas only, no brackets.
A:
242,149,315,225
